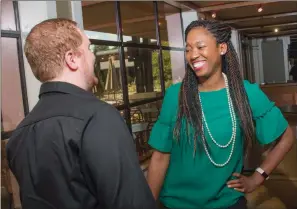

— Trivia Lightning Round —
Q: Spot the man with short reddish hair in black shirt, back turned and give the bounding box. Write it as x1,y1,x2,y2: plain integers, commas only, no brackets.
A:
7,19,156,209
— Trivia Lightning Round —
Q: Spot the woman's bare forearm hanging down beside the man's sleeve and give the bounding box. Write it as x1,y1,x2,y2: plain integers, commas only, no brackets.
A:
147,151,170,200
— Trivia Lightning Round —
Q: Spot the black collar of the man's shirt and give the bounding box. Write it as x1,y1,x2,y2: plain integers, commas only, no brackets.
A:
39,81,95,98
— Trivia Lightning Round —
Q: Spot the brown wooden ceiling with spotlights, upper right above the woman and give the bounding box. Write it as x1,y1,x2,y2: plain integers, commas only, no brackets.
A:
181,0,297,38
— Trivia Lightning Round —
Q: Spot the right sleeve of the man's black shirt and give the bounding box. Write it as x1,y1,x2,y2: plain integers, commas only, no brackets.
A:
81,106,157,209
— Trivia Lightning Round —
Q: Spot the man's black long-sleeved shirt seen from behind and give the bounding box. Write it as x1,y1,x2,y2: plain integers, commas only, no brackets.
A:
6,82,156,209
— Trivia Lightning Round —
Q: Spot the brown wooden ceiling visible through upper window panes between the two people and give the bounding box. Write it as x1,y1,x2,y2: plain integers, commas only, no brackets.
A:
82,1,182,41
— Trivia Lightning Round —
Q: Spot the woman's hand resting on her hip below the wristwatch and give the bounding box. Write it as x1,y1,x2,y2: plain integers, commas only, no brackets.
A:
227,173,264,193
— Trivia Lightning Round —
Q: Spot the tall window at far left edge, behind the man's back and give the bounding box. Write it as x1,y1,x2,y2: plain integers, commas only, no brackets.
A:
1,0,28,138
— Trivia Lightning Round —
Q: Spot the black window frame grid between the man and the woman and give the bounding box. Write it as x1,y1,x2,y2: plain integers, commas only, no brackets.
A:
90,1,186,133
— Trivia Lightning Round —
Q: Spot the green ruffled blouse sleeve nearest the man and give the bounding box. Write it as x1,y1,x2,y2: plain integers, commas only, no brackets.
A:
149,86,178,153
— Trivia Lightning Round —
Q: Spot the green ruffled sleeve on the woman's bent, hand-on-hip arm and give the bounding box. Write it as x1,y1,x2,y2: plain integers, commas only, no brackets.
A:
246,82,288,144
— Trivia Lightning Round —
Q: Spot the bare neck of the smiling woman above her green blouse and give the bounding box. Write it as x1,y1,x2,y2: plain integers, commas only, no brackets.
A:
198,71,225,92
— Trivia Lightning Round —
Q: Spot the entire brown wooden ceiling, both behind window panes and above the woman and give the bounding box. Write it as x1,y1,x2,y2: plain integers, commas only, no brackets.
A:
82,0,297,40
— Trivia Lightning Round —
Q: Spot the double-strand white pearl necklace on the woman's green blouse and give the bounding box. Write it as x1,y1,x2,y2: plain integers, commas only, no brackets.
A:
199,73,236,167
